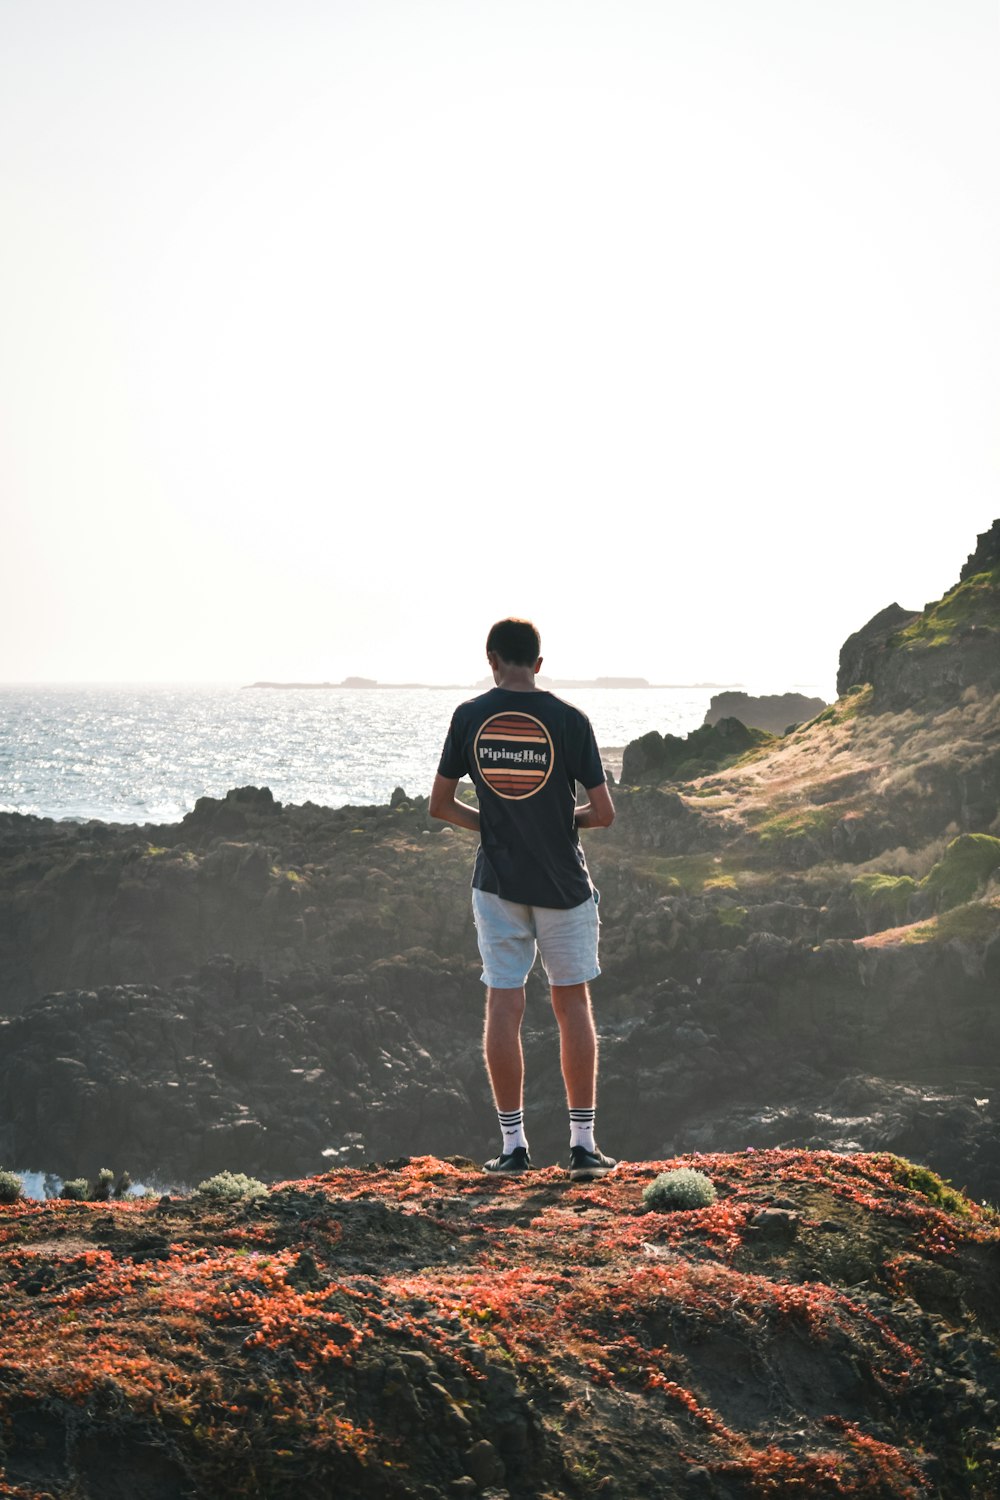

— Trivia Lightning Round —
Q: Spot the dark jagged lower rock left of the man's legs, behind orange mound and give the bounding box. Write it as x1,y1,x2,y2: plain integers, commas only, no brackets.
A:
0,953,489,1182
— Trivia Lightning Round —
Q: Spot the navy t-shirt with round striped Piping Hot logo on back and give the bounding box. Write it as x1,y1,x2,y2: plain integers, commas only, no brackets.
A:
438,687,606,909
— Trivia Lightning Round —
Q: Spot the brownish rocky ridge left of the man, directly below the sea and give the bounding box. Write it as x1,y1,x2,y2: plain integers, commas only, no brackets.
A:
0,788,472,1014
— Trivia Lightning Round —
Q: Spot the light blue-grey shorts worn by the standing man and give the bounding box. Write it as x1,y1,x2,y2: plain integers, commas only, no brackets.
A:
472,890,601,990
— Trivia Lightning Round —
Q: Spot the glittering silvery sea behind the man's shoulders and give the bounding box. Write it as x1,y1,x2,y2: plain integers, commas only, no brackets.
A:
0,684,728,824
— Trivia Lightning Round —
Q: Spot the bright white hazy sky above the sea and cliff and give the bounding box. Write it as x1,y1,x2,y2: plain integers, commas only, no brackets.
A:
0,0,1000,695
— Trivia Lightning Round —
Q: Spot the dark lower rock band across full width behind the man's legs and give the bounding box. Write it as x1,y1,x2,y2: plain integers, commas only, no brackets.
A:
0,885,1000,1197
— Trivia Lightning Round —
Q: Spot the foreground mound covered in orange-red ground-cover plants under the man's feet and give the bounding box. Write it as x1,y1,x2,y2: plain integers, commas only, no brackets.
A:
0,1151,1000,1500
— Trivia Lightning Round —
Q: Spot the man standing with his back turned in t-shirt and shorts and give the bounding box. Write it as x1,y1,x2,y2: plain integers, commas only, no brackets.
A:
430,620,618,1179
